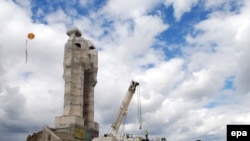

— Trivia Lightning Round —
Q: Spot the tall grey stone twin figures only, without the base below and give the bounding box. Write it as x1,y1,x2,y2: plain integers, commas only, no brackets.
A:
56,27,98,127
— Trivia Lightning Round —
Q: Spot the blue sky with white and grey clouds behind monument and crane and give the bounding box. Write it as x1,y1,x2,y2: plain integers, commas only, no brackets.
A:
0,0,250,141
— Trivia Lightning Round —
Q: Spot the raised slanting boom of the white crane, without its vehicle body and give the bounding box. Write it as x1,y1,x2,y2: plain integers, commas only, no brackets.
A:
111,80,139,136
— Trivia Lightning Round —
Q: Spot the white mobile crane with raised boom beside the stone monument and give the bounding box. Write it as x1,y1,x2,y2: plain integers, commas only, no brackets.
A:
92,81,139,141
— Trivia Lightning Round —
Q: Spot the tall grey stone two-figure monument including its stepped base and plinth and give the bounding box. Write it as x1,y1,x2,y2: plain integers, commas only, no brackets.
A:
27,26,99,141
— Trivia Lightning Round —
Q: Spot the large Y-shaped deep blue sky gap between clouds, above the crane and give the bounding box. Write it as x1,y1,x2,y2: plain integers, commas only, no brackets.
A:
149,3,211,59
